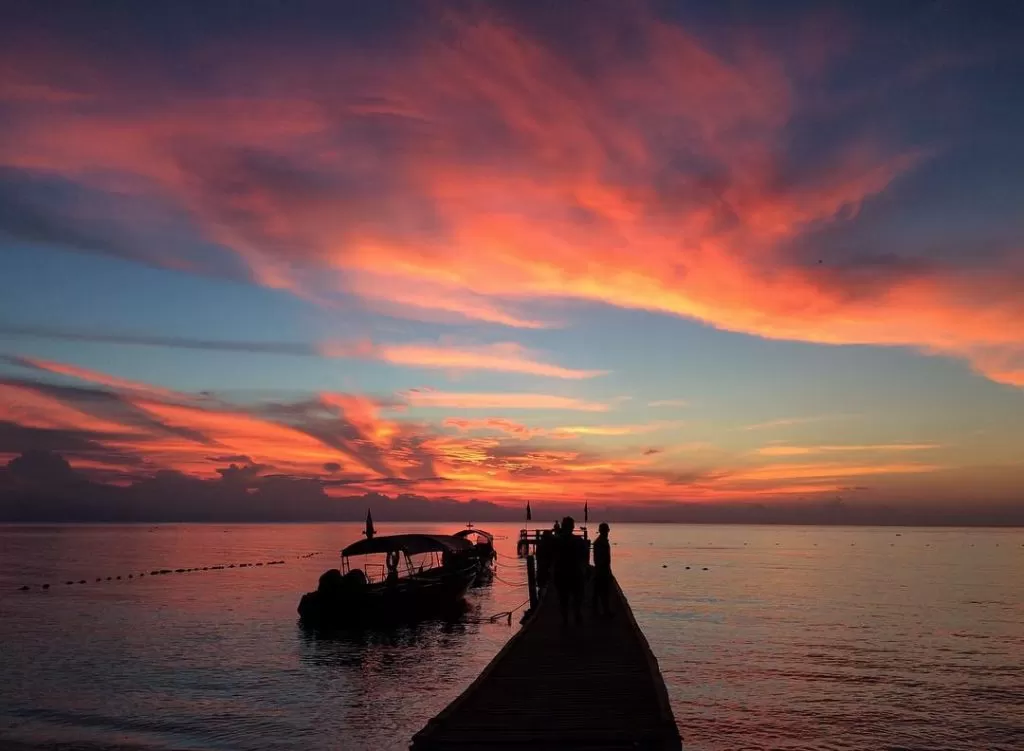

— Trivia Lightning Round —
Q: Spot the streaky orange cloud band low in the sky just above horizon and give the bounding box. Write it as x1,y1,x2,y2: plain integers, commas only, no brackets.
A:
0,363,999,503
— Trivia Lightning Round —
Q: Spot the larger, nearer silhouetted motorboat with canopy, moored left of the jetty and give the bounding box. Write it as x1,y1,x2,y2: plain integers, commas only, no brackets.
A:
299,534,478,626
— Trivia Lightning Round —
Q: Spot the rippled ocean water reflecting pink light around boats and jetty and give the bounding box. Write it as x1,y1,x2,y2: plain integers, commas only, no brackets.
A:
0,525,1024,751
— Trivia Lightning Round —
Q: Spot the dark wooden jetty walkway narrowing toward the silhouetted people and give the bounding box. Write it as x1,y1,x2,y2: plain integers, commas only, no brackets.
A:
412,569,682,751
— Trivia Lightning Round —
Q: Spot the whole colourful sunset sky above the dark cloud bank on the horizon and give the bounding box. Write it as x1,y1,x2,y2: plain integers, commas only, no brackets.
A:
0,1,1024,516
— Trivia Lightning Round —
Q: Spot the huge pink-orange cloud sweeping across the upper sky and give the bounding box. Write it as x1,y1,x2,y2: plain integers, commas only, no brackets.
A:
0,9,1024,385
